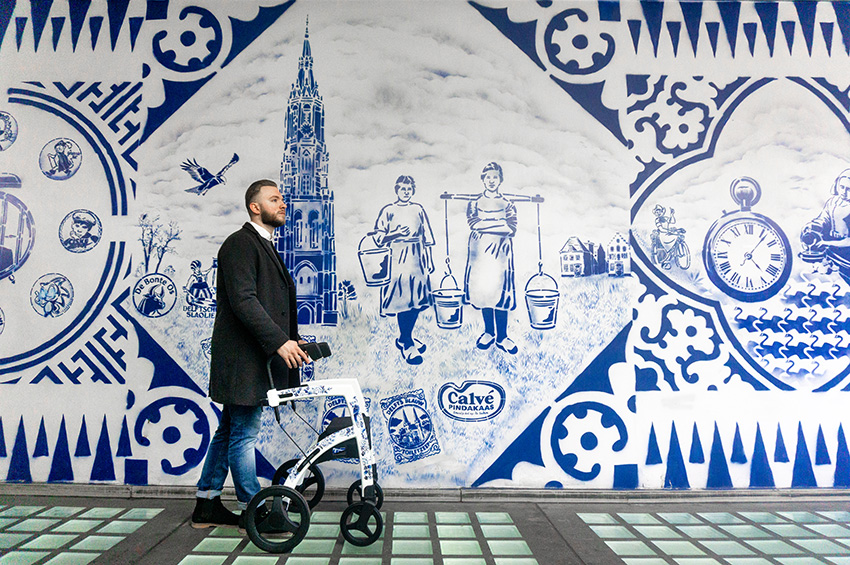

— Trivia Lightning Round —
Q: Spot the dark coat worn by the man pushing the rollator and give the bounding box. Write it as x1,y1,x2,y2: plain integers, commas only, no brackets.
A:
210,223,299,406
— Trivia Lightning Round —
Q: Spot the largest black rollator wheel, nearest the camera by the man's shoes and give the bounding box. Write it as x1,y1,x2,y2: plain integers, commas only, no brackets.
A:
245,485,310,553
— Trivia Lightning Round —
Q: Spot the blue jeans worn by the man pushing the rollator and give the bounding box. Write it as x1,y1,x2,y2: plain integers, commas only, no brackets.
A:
197,404,263,510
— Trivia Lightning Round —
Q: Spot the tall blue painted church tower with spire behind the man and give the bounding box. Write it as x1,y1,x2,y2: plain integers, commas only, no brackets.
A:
276,25,338,326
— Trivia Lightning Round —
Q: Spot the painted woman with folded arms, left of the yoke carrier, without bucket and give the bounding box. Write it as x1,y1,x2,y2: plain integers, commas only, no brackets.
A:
372,175,434,365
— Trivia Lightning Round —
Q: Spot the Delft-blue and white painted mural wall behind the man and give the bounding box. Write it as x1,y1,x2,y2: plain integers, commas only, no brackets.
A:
0,0,850,489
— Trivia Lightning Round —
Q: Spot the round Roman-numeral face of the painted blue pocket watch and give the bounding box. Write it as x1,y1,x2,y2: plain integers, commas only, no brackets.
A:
706,216,790,300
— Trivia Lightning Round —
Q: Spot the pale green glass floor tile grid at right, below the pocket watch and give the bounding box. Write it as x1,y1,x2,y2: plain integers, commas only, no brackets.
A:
579,511,850,565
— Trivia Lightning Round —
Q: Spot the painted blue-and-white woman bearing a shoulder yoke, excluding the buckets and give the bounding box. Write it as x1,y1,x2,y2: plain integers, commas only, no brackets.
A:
464,163,517,354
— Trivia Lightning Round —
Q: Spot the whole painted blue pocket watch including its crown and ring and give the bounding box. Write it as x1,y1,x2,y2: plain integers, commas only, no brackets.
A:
702,177,791,302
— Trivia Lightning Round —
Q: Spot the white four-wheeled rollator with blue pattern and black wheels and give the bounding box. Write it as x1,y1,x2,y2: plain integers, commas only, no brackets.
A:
245,344,384,553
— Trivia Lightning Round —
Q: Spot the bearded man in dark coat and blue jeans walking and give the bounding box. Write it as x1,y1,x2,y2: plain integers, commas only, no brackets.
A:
192,180,310,528
